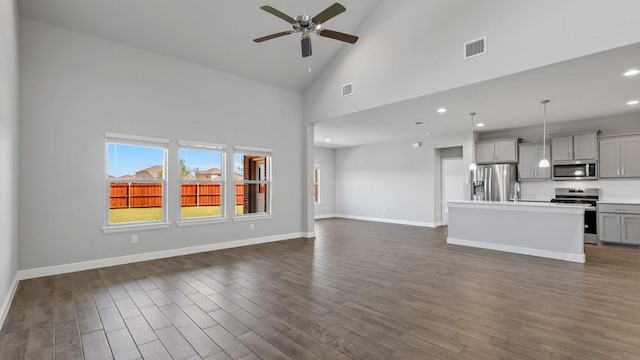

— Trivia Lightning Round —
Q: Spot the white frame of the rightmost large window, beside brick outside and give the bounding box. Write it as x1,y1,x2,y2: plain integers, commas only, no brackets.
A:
232,145,273,221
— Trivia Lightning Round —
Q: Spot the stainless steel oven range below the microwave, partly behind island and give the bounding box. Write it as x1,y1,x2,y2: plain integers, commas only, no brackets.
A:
551,188,600,244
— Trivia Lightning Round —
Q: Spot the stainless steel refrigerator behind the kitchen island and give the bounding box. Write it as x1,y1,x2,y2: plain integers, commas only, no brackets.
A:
469,164,520,201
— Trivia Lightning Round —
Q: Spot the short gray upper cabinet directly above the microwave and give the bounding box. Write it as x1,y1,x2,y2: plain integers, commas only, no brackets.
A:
551,131,599,161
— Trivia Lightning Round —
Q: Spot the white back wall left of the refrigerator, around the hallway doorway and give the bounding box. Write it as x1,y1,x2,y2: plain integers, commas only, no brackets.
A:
336,134,471,227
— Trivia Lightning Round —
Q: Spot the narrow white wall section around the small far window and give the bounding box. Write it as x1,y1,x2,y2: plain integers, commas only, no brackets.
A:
313,146,336,218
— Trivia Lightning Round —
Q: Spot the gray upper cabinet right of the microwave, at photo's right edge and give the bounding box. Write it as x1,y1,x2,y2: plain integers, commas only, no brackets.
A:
600,135,640,178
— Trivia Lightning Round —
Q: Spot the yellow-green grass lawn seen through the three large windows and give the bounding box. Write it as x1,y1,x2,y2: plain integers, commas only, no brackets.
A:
109,205,242,224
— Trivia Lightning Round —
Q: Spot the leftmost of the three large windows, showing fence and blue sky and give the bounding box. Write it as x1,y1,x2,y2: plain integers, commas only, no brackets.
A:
105,133,169,228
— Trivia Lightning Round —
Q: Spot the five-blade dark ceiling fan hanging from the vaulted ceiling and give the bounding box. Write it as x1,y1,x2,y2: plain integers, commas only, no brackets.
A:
253,3,358,57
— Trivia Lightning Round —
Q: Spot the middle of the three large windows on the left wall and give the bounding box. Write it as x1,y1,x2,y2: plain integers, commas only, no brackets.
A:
179,140,226,220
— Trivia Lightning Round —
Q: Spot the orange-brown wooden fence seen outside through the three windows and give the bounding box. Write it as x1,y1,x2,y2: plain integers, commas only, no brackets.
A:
109,182,244,209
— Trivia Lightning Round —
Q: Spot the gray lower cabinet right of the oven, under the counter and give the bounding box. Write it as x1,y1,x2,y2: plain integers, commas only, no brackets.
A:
598,204,640,244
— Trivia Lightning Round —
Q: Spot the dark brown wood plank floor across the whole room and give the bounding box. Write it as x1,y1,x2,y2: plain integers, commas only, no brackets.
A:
0,219,640,360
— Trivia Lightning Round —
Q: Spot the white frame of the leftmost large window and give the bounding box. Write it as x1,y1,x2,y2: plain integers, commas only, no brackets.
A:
102,132,170,233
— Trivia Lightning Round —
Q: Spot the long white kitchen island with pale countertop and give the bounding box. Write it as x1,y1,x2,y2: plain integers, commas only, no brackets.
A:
447,200,585,263
